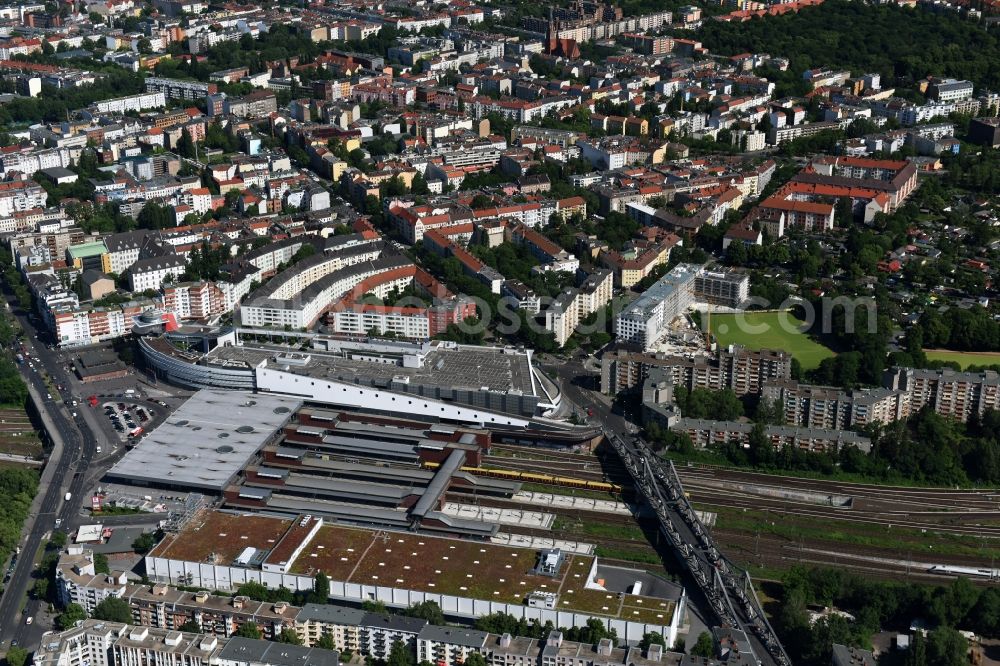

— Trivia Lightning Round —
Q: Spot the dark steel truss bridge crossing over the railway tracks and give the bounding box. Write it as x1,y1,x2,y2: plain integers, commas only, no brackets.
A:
607,433,792,666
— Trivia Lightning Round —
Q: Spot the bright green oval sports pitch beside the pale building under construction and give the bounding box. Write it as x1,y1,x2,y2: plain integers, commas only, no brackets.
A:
701,312,833,370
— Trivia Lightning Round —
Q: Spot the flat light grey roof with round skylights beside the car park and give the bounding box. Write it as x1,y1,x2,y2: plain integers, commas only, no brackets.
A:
108,389,302,494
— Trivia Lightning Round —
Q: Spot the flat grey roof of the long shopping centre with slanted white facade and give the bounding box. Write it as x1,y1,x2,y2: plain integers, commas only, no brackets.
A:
209,344,538,396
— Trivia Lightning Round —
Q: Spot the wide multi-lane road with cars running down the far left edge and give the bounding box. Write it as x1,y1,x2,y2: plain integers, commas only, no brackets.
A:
0,304,97,650
